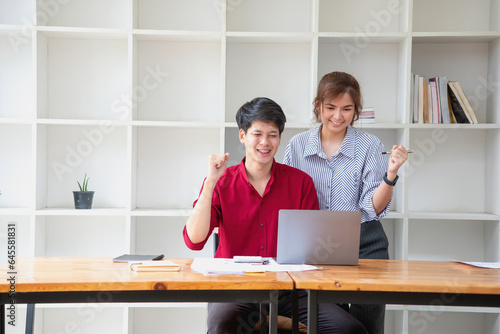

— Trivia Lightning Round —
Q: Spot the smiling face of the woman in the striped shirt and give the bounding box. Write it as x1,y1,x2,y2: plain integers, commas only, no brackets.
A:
319,94,355,133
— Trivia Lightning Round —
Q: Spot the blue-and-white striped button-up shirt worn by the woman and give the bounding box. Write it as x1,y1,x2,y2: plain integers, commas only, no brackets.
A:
283,124,390,222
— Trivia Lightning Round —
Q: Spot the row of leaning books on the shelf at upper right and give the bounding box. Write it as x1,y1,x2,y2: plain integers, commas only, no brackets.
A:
412,74,478,124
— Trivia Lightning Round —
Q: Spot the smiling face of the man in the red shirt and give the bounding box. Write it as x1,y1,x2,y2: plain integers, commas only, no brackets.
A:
240,121,281,164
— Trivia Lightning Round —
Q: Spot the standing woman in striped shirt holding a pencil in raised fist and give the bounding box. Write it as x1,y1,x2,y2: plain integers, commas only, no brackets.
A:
284,72,408,334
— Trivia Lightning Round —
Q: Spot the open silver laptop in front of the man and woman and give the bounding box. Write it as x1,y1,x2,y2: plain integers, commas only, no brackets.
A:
276,210,361,265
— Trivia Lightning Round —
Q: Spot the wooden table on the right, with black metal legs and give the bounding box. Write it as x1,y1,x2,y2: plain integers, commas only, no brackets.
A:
289,260,500,334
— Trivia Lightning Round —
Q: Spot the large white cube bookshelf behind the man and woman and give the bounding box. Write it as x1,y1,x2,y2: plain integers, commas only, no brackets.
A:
0,0,500,334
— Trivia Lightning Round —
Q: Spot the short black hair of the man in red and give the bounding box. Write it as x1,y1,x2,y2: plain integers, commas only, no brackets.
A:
236,97,286,135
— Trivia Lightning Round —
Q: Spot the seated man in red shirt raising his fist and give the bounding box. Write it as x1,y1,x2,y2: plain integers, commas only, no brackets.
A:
183,98,366,334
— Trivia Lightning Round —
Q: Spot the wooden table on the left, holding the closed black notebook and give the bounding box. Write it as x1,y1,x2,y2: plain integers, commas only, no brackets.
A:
0,257,293,333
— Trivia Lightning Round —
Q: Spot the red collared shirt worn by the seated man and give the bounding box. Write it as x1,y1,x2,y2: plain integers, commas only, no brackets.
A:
183,159,319,258
